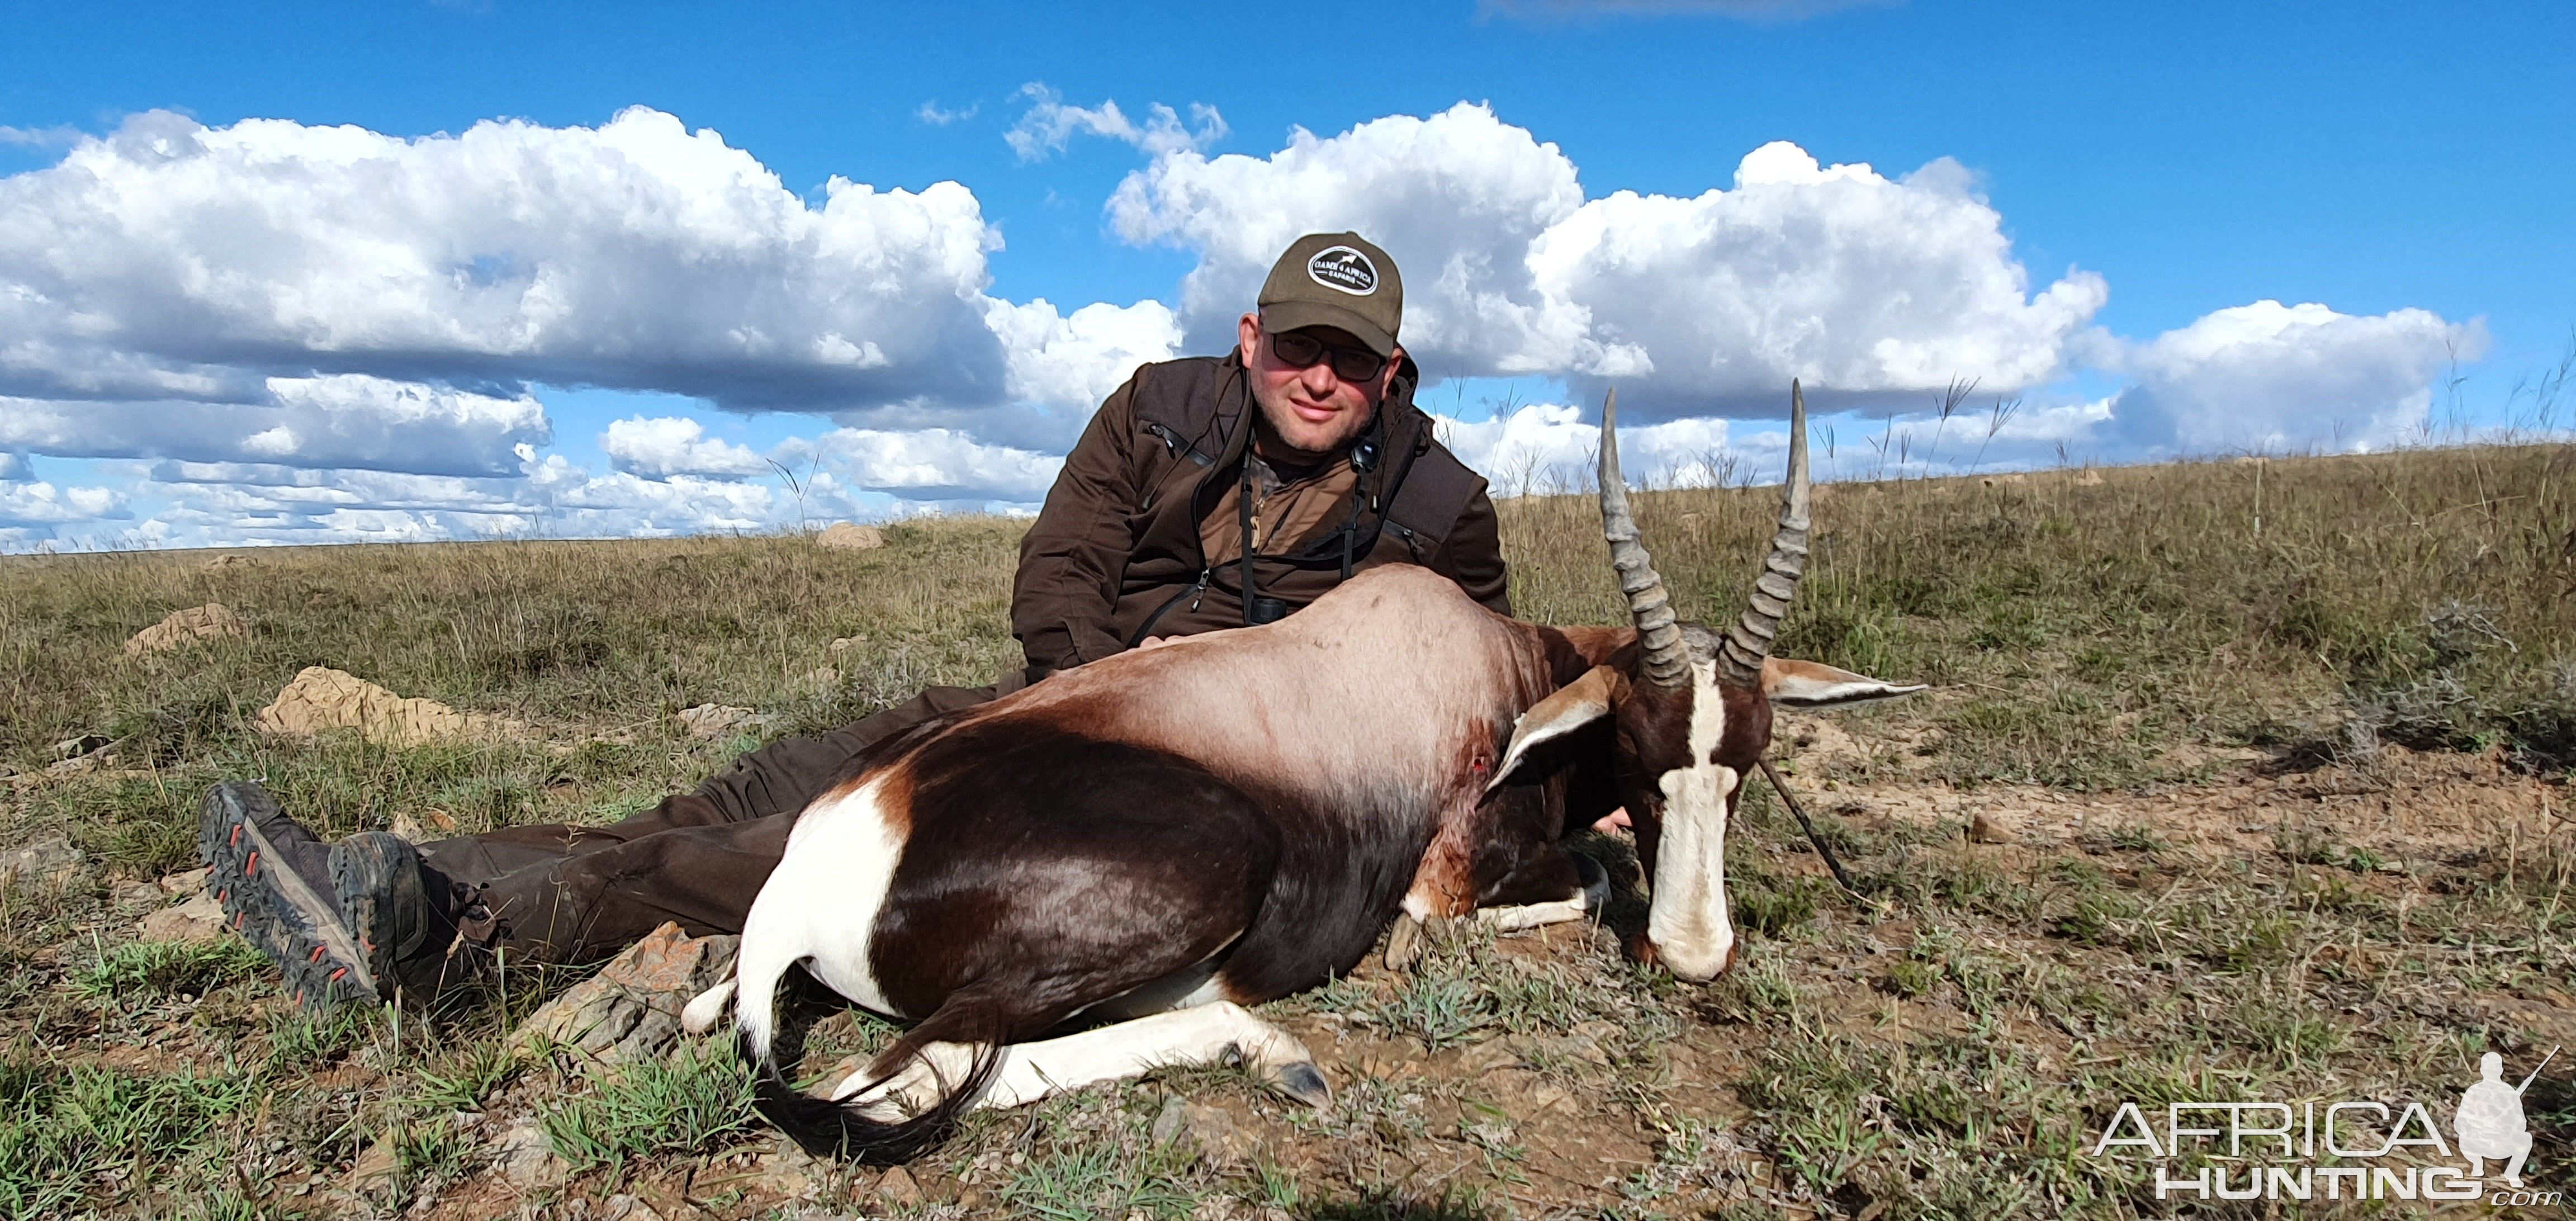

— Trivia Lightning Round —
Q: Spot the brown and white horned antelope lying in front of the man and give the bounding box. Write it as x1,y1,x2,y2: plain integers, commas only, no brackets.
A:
705,386,1919,1159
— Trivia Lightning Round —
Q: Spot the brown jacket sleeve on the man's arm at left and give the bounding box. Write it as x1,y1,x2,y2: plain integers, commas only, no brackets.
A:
1010,378,1139,670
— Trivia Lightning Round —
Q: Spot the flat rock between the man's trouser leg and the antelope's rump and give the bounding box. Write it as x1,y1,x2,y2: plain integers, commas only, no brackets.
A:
510,922,742,1064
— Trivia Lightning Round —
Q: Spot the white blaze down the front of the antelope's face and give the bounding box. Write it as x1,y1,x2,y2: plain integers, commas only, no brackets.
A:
1646,662,1736,981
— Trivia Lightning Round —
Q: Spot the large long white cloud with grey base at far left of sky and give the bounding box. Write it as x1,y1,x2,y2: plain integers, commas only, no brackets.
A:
0,108,1002,410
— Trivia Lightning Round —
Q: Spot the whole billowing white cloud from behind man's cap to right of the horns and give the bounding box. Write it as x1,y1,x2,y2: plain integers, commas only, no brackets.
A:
1110,103,2107,417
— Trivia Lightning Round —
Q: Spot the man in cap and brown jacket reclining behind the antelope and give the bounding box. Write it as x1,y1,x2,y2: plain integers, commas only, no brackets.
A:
198,232,1509,1007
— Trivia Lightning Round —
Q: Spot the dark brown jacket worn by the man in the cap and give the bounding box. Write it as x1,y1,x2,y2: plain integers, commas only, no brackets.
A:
1010,356,1512,673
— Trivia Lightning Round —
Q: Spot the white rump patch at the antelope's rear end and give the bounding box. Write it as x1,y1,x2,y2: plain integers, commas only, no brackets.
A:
742,780,904,1015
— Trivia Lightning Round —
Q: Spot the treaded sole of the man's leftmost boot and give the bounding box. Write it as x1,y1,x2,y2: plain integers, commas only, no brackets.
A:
196,788,376,1012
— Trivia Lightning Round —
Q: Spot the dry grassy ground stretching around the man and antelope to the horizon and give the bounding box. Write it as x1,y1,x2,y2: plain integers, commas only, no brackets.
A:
0,446,2576,1218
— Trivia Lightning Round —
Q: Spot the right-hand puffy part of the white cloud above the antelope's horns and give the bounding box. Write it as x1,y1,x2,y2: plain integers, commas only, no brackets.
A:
1530,141,2110,412
